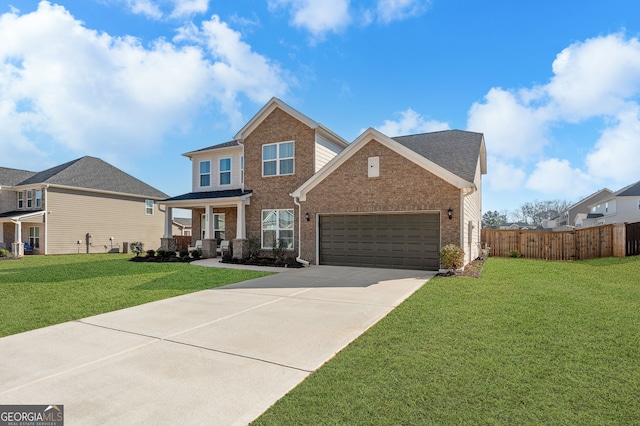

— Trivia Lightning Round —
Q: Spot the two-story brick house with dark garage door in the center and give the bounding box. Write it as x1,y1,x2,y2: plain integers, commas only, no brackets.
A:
162,98,486,270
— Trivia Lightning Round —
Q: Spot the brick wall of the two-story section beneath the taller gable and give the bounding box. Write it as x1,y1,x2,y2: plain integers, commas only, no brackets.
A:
244,108,315,254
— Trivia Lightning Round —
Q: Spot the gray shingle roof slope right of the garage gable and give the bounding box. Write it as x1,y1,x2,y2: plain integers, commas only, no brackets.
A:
391,130,483,182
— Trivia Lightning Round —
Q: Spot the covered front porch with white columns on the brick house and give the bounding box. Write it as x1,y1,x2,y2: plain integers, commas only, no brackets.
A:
159,189,252,258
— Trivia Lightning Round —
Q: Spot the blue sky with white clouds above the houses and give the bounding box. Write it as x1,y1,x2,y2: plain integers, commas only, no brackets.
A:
0,0,640,218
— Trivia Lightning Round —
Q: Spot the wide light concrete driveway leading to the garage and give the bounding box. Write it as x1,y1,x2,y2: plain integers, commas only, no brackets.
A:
0,266,433,425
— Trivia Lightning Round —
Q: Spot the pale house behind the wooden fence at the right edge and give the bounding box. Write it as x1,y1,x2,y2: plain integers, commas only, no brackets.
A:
576,181,640,227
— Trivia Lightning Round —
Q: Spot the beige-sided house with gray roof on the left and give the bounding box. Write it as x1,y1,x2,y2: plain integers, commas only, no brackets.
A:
0,157,167,255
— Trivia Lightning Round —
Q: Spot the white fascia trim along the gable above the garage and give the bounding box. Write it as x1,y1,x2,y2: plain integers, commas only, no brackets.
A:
290,127,475,201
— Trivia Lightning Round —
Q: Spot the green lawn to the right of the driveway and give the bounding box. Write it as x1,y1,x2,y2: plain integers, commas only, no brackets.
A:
255,257,640,425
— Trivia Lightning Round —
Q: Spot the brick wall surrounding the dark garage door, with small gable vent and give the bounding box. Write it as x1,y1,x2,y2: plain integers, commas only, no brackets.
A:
296,141,460,264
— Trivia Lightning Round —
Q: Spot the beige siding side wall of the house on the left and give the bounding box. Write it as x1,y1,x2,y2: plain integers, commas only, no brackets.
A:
41,188,164,254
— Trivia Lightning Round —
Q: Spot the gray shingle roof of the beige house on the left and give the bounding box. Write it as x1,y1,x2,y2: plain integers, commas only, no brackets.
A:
0,156,167,199
